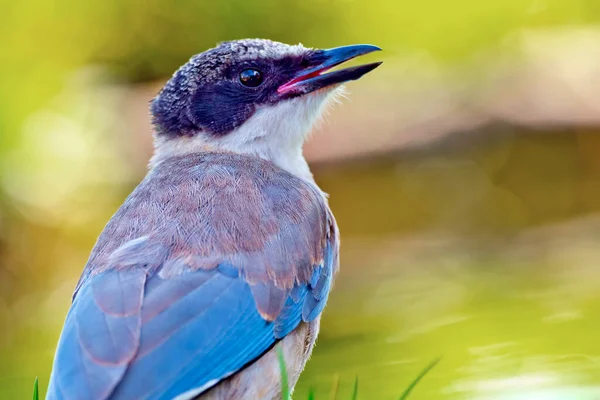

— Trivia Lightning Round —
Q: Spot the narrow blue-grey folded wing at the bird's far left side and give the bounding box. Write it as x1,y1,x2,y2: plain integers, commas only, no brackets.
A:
47,270,146,399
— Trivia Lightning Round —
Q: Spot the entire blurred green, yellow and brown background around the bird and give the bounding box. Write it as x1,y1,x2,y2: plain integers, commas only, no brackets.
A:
0,0,600,400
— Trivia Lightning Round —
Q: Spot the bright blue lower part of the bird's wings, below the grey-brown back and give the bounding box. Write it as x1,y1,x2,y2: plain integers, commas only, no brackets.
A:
48,239,333,399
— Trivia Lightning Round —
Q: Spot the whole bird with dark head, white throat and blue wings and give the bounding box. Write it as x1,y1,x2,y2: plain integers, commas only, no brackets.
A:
46,39,381,400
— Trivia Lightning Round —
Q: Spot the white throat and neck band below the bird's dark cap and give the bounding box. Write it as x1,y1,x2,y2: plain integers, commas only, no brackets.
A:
150,87,343,183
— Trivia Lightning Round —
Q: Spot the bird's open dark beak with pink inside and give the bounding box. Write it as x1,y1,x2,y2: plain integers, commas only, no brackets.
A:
277,44,381,95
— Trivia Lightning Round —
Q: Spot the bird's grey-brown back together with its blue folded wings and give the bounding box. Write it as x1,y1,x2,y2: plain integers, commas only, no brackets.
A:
47,153,338,400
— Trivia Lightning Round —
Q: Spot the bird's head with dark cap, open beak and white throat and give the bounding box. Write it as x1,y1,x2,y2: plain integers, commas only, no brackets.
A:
151,39,381,177
